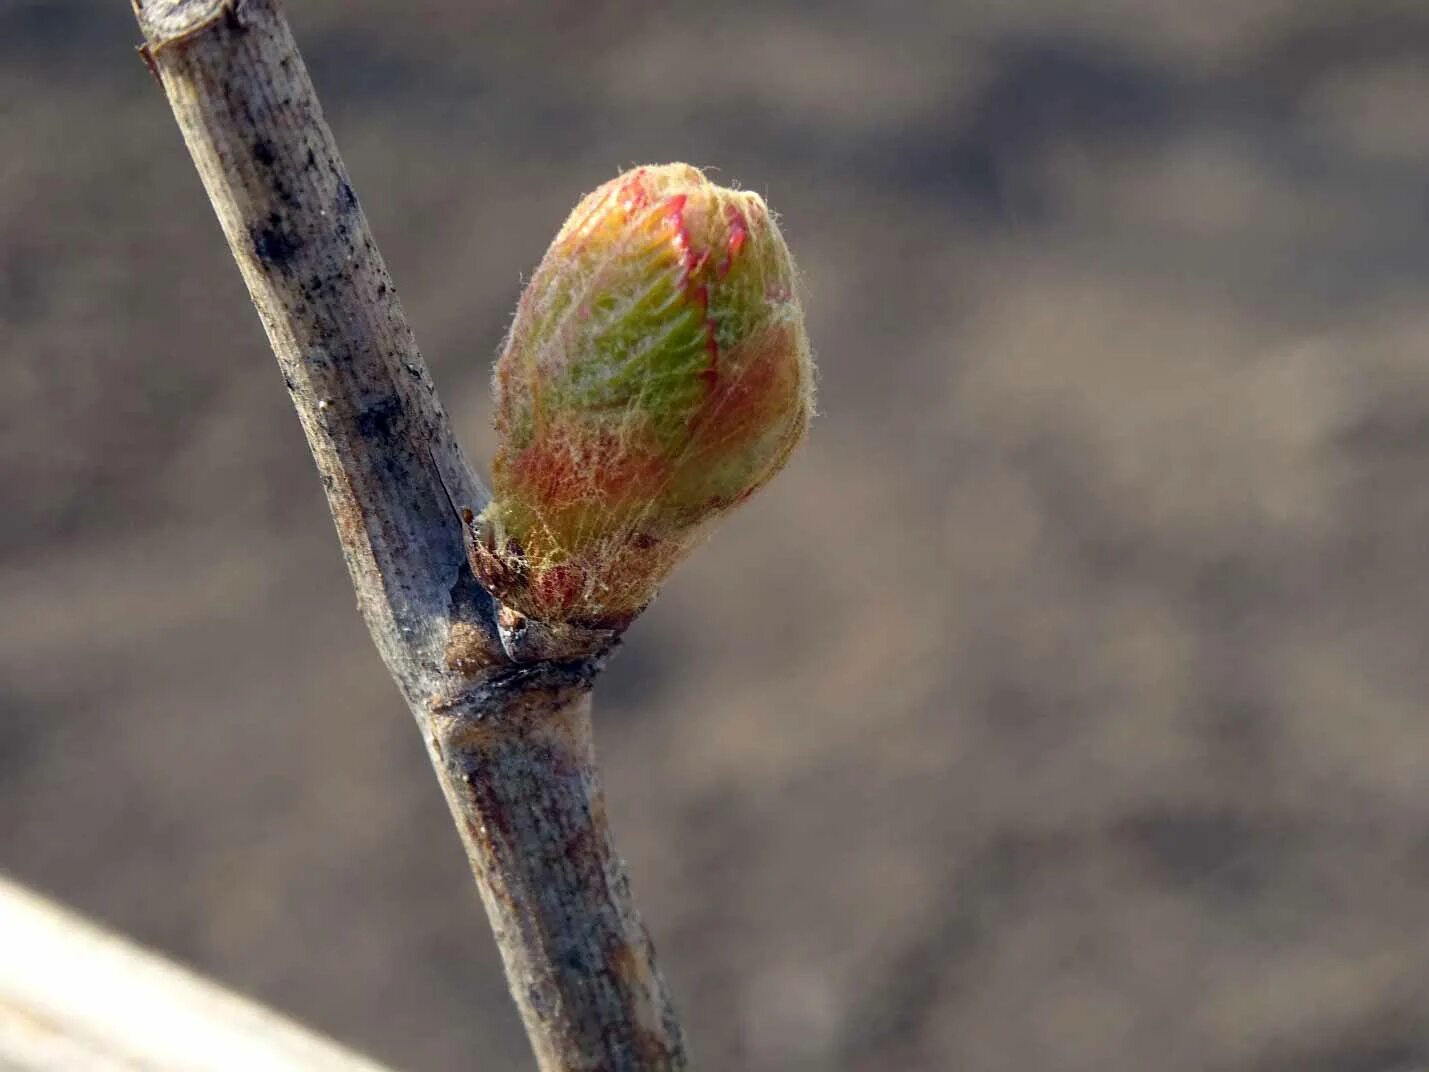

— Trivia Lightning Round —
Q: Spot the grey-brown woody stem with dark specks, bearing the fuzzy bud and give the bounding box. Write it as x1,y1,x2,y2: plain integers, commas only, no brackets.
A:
136,0,686,1072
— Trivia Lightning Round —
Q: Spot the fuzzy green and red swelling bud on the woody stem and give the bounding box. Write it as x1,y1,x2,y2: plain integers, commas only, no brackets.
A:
472,164,813,629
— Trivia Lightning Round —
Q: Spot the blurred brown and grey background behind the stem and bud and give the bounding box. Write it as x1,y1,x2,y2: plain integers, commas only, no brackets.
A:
0,0,1429,1072
